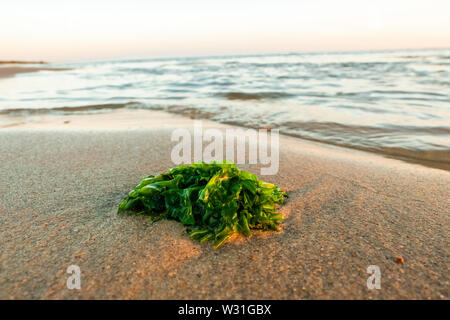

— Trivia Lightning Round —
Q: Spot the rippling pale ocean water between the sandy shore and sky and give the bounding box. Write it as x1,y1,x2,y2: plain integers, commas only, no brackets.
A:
0,50,450,165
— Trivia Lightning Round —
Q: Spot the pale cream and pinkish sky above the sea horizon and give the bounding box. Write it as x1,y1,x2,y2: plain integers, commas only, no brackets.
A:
0,0,450,61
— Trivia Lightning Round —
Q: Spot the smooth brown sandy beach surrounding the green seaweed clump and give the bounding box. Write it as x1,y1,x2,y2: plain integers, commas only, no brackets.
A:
0,110,450,299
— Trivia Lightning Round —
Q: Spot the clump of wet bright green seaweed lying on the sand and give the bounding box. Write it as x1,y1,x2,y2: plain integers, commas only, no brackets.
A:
118,161,287,248
